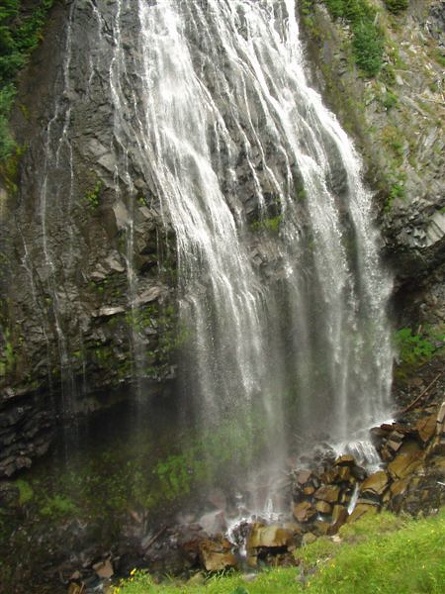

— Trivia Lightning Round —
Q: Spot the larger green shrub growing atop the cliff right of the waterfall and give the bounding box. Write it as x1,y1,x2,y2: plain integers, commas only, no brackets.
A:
325,0,384,77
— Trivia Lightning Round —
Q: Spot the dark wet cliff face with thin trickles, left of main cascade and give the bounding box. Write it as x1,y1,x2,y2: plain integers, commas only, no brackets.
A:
0,0,176,474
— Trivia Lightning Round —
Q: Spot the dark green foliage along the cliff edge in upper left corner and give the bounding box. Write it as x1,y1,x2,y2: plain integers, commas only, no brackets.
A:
0,0,54,161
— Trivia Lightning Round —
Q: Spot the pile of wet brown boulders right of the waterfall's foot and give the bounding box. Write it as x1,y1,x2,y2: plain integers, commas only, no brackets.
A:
293,402,445,541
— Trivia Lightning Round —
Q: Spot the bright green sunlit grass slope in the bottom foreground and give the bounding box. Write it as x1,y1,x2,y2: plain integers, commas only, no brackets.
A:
113,510,445,594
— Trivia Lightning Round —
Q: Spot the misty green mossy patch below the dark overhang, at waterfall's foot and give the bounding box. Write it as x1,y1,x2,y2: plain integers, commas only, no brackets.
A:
7,404,264,528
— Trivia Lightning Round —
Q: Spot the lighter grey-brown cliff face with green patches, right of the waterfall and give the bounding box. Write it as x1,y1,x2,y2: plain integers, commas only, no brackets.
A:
301,0,445,325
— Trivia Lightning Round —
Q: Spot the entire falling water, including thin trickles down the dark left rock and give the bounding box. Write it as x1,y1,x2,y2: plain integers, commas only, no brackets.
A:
0,0,392,588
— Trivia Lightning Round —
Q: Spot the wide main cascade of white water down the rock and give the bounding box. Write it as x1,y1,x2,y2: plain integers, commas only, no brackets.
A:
95,0,392,500
